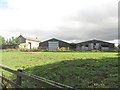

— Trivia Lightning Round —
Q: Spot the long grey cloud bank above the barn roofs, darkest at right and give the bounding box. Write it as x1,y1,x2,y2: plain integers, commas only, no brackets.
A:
8,3,118,41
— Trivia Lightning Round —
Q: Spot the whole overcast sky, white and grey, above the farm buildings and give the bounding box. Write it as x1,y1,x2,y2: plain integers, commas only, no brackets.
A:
0,0,119,43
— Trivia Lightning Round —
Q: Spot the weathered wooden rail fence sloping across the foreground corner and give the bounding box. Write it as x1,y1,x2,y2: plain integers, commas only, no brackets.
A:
0,66,75,90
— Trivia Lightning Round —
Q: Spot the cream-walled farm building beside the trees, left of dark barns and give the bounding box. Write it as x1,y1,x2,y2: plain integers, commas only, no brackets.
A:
18,35,40,49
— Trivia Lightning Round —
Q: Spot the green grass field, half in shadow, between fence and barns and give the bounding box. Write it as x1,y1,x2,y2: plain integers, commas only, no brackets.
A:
2,51,118,88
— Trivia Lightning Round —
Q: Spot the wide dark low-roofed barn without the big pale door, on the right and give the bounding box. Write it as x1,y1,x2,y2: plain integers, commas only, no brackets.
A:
76,40,114,51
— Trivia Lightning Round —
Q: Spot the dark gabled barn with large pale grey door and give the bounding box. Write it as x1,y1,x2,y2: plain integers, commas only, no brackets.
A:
40,38,70,51
